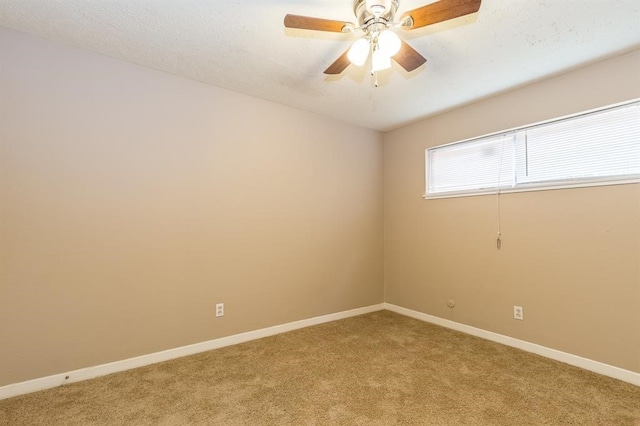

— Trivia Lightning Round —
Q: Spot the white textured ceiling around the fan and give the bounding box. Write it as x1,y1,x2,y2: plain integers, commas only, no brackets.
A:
0,0,640,131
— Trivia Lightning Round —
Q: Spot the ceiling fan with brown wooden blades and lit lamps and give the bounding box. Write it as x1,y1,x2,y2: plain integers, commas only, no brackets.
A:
284,0,482,81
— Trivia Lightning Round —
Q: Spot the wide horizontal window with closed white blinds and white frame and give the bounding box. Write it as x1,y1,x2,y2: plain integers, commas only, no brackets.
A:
425,100,640,197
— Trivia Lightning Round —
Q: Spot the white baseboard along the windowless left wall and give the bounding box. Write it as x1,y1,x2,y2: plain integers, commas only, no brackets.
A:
0,303,384,400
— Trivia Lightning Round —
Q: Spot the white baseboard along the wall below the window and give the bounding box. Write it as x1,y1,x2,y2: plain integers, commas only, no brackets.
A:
384,303,640,386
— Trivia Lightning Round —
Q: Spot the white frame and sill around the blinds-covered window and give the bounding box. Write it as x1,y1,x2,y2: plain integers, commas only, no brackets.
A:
423,98,640,200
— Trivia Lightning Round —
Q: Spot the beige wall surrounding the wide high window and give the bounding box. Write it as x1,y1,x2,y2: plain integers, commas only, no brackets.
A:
384,51,640,372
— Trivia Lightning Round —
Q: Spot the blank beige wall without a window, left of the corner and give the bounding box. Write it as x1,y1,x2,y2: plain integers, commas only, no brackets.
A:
0,30,383,386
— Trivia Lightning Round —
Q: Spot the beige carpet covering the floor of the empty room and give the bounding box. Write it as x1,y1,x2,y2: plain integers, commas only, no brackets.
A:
0,311,640,425
